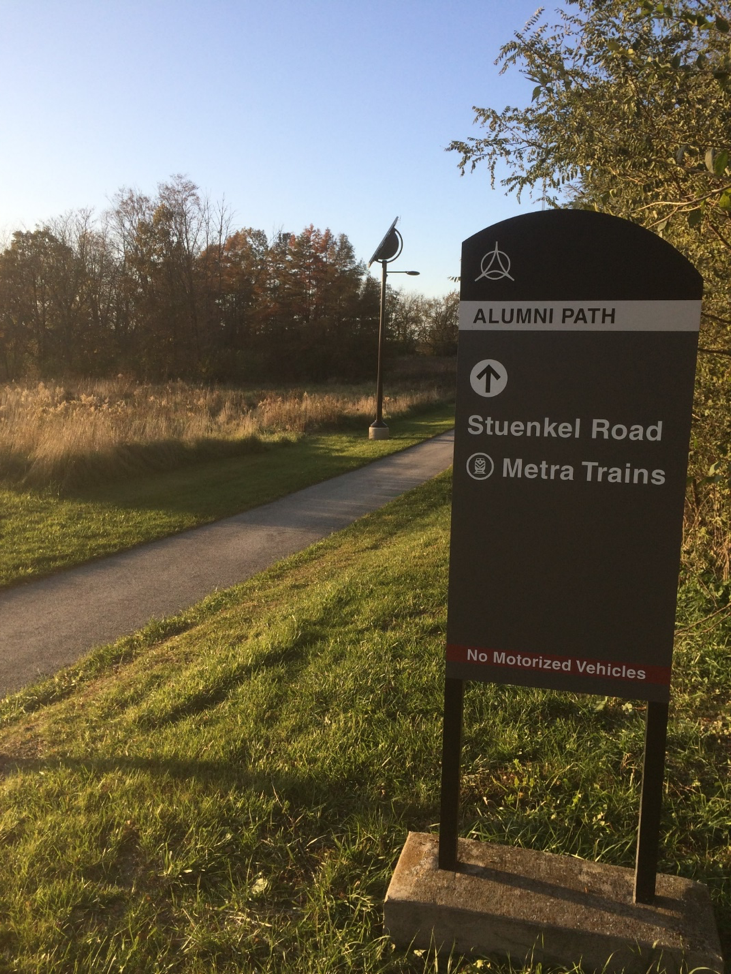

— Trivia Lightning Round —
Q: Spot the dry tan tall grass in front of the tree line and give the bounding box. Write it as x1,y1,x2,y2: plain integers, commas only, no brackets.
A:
0,377,454,488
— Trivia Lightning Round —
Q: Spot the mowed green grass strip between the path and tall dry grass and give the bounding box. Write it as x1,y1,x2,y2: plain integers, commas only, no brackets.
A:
0,404,454,587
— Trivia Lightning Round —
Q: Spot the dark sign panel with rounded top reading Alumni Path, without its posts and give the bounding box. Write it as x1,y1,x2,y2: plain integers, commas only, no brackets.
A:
447,210,702,701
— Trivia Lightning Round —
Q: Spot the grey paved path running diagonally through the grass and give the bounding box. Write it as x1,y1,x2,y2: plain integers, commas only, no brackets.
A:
0,432,454,697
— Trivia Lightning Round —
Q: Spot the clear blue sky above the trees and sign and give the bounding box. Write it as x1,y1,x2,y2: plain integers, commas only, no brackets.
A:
0,0,538,295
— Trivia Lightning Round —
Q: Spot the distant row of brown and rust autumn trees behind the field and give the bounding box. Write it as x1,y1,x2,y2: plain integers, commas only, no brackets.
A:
0,176,457,383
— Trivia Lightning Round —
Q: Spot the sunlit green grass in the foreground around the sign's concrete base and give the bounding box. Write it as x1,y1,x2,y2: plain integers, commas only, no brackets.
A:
0,475,731,974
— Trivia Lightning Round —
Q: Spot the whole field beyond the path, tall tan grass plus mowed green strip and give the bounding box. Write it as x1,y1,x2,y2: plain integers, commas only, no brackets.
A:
0,383,454,586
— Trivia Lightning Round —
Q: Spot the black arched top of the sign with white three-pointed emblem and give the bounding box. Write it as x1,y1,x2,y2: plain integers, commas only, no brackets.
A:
461,210,703,301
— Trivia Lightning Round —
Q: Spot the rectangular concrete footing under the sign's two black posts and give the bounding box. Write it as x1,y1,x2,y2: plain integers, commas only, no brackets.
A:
384,832,723,974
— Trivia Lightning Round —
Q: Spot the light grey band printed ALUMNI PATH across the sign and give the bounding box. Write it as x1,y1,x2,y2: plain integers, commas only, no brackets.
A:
459,300,701,331
